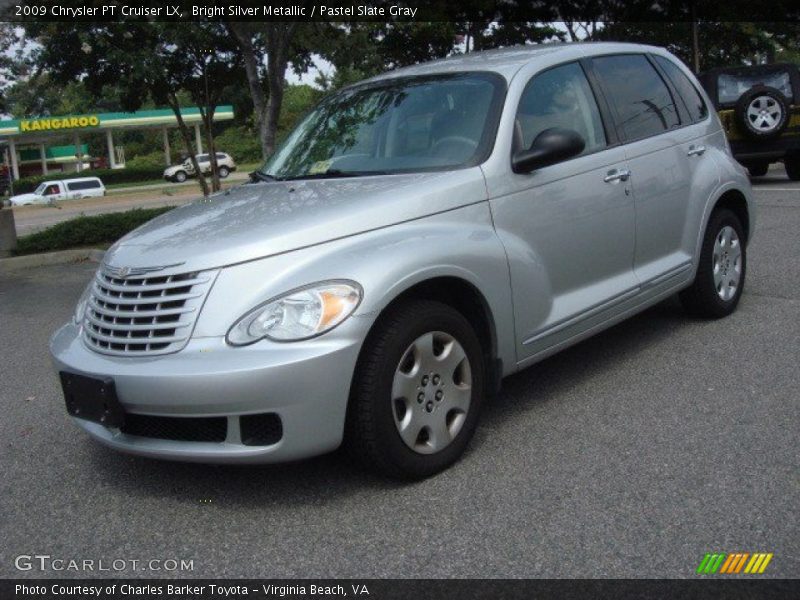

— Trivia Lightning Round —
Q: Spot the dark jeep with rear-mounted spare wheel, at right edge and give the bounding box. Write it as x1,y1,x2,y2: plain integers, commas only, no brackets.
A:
700,63,800,181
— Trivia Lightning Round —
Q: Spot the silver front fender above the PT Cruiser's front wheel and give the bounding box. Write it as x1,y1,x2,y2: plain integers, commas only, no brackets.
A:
193,201,517,374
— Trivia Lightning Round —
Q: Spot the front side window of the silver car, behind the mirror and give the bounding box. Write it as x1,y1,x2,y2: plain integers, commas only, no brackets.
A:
515,63,606,154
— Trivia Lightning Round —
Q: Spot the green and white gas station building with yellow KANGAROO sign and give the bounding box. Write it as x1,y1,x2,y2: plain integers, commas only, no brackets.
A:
0,105,233,179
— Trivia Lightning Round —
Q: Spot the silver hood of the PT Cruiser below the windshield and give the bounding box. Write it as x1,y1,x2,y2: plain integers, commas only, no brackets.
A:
105,167,487,271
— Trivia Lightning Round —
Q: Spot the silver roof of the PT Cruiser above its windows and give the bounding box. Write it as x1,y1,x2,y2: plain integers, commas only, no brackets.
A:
356,42,666,85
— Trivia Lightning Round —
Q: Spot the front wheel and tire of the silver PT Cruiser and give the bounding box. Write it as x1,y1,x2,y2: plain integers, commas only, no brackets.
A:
345,300,486,480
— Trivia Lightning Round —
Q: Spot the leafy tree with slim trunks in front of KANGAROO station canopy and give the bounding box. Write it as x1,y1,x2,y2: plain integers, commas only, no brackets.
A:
25,20,244,195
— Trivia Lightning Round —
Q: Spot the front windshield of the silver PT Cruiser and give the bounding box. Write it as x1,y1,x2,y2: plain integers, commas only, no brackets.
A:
260,73,505,179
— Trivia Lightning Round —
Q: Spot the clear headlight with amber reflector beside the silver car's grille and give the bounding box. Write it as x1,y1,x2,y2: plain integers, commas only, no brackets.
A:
227,281,362,346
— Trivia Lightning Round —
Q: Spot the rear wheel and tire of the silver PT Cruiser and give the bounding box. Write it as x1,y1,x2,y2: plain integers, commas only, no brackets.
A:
680,209,747,319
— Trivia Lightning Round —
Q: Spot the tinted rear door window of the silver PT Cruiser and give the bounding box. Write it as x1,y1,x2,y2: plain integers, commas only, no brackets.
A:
592,54,679,141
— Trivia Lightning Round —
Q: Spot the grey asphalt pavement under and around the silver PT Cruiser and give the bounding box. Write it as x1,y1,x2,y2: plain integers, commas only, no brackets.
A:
0,176,800,577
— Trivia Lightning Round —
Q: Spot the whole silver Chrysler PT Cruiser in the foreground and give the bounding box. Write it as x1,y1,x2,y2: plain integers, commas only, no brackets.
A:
51,43,754,478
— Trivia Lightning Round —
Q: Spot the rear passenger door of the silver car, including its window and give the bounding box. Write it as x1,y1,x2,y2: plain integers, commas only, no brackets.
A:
591,54,694,290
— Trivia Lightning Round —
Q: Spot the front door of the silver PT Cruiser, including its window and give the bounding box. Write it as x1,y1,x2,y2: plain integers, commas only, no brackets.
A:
491,62,637,361
